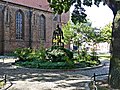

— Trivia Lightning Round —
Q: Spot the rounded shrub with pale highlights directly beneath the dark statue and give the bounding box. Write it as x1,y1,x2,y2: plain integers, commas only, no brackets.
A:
46,46,73,62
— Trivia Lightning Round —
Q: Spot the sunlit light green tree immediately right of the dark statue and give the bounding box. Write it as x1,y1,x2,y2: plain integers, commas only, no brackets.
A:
62,22,95,46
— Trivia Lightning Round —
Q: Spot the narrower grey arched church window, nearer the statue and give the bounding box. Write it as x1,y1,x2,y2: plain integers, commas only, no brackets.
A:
40,15,46,40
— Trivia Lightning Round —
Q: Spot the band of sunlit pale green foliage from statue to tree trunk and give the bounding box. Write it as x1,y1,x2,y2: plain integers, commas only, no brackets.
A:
62,21,112,45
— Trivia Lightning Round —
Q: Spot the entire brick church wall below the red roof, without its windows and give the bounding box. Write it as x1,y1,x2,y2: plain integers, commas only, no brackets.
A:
0,2,53,53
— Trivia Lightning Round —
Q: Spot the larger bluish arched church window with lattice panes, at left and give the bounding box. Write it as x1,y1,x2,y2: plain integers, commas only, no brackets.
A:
16,10,24,39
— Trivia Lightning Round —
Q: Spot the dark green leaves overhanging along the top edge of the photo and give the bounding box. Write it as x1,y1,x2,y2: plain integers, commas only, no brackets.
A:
48,0,116,24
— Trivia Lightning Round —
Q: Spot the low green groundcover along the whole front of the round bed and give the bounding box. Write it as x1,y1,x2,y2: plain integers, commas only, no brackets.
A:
14,60,99,69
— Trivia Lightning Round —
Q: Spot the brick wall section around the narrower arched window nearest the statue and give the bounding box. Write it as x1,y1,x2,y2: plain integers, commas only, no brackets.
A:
32,10,53,48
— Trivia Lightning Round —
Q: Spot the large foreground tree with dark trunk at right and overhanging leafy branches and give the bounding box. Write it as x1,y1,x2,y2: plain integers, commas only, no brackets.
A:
48,0,120,89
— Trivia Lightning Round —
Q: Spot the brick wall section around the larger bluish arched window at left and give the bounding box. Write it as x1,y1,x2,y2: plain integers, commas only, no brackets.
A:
4,4,29,53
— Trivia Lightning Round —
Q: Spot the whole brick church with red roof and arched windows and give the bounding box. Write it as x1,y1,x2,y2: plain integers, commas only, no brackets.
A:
0,0,69,54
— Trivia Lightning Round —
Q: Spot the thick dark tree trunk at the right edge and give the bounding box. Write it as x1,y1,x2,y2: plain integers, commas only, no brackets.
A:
109,5,120,89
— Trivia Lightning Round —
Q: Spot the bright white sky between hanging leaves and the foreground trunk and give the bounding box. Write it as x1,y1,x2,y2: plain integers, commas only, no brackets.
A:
71,3,113,28
